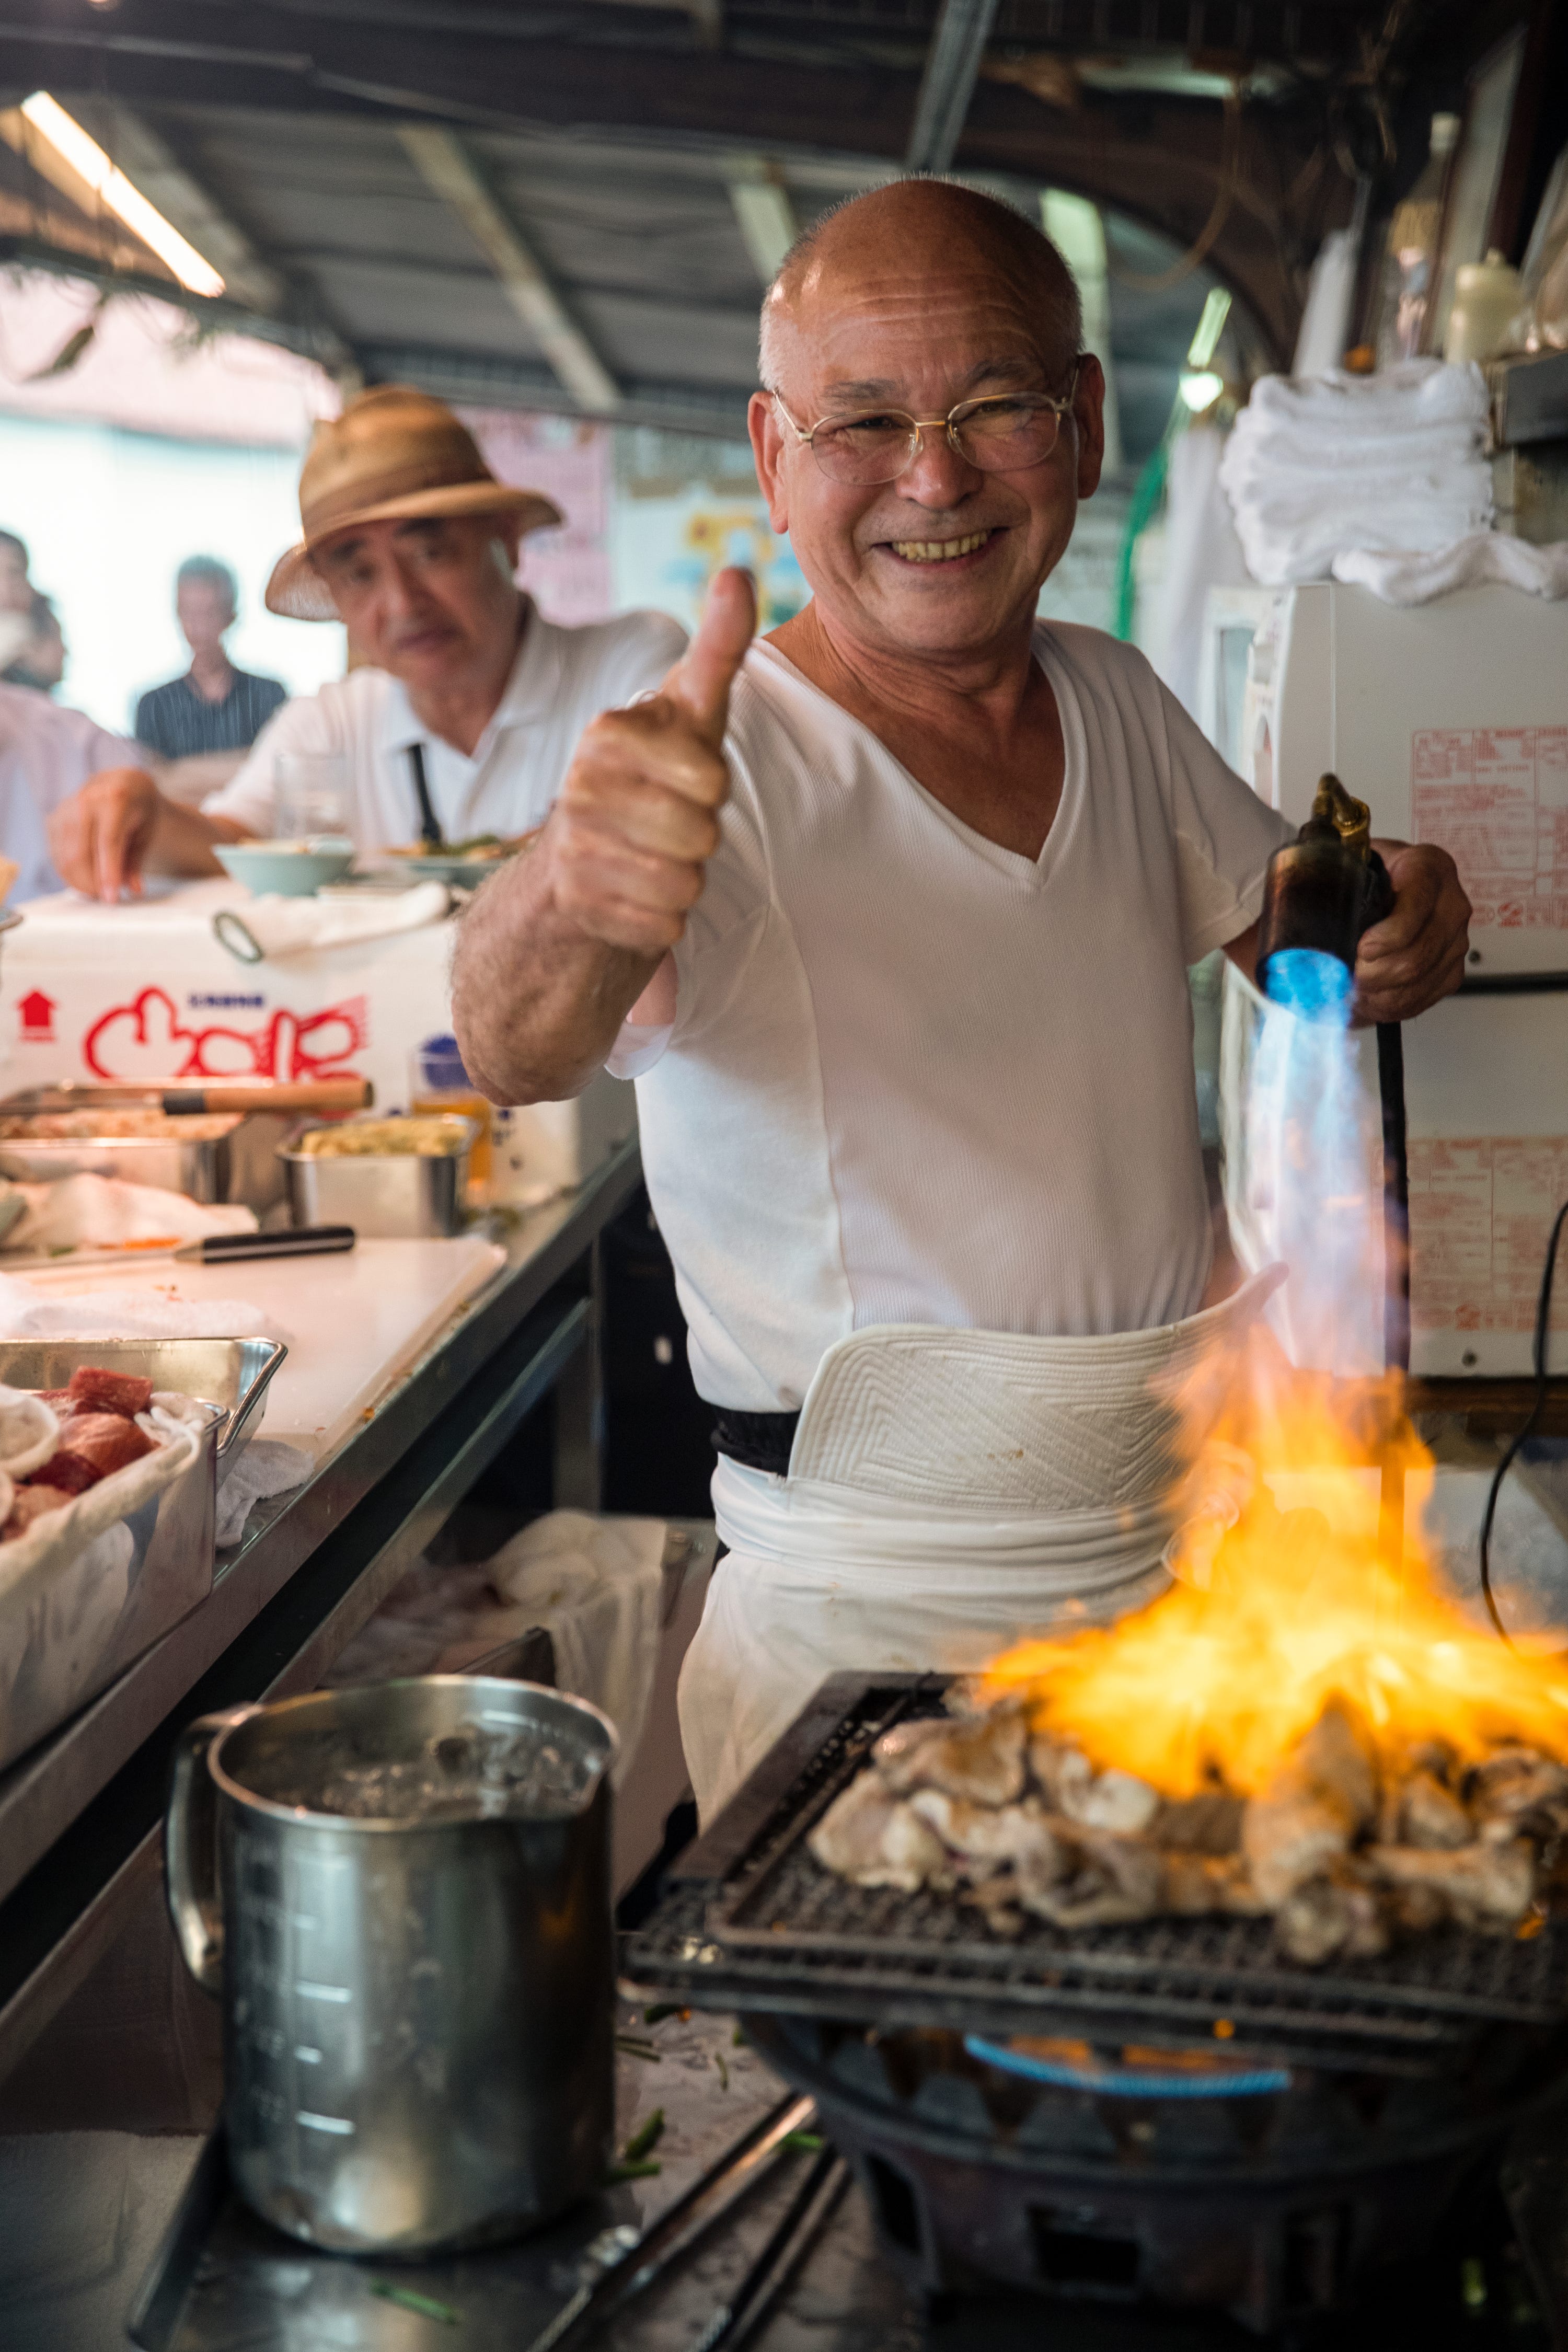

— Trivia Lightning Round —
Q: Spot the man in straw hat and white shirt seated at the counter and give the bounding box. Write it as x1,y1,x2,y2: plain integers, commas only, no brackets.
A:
49,384,684,901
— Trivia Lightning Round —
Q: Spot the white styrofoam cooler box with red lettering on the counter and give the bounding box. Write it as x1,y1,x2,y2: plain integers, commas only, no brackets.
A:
0,880,637,1200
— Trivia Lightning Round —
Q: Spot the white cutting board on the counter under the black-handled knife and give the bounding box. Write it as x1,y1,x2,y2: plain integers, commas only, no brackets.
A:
7,1235,505,1461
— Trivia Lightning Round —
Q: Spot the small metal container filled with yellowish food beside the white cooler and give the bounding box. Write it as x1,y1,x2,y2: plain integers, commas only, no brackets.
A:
278,1113,477,1242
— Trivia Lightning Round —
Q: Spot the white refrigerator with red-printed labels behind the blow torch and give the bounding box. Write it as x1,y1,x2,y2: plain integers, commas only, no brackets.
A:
1215,581,1568,1376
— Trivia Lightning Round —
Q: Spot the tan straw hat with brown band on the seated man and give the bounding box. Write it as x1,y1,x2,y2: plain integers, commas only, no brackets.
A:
266,384,562,621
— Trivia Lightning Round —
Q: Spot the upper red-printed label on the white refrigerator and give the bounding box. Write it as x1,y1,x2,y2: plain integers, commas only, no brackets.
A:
1411,727,1568,931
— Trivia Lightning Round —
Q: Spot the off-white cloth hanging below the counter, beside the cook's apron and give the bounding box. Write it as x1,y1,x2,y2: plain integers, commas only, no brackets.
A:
489,1510,665,1783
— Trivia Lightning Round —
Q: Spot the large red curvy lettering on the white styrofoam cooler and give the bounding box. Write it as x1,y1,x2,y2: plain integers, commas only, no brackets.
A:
83,988,369,1085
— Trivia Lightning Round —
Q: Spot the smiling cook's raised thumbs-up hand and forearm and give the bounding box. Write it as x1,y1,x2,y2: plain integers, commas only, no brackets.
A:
452,572,757,1103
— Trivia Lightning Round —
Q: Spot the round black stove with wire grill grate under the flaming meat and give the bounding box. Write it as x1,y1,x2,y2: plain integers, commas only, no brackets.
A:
628,1675,1568,2352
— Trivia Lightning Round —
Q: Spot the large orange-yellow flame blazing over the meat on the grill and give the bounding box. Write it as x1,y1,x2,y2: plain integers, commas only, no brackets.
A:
981,1341,1568,1797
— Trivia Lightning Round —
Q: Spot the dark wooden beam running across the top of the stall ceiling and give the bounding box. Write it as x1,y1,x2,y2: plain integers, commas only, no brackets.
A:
0,0,1352,365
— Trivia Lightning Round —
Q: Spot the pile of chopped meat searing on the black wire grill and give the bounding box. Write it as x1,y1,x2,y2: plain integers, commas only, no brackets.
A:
809,1698,1568,1966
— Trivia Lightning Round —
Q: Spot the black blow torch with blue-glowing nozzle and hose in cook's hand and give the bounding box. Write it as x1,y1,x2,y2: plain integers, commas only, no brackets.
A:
1258,776,1411,1562
